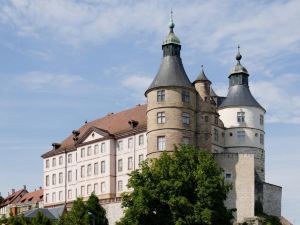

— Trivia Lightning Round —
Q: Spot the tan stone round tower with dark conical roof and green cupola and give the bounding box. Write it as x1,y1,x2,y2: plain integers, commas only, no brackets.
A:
145,15,196,158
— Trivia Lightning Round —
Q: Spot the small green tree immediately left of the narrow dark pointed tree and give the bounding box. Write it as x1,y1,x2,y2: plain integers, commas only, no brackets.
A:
63,198,90,225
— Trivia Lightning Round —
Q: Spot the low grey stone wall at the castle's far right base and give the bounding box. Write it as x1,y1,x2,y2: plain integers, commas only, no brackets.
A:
262,183,282,217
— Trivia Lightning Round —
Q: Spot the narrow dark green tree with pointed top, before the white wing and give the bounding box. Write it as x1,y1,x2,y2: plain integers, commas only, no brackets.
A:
86,193,108,225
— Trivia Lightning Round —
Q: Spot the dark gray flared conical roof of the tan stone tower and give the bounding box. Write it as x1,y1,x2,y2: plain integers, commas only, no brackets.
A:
145,56,194,95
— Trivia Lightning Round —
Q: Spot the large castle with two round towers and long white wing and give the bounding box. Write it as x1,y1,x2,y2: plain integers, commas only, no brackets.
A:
42,16,282,224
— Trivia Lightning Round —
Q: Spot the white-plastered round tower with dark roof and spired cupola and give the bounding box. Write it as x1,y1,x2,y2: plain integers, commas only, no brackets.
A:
218,49,266,181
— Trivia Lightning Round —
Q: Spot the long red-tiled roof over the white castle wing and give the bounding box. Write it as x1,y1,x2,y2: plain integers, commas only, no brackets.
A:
42,105,147,158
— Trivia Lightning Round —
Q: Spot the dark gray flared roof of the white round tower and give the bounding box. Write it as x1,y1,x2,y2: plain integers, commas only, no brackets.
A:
219,85,265,111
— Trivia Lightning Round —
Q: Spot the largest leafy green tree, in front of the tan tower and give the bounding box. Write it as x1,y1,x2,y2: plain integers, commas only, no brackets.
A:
118,145,233,225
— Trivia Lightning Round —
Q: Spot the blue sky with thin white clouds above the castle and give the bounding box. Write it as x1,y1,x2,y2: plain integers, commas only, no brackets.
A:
0,0,300,225
